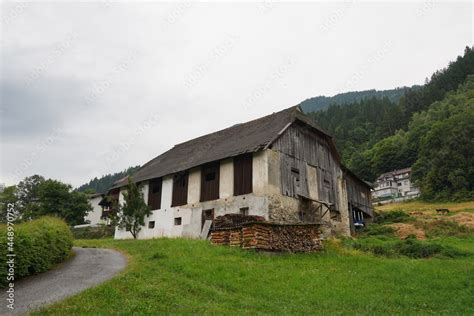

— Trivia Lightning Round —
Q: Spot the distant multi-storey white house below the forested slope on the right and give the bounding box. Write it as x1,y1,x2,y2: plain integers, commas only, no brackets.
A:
372,168,420,203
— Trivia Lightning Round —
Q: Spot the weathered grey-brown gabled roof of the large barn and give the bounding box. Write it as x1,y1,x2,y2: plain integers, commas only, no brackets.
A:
113,106,339,188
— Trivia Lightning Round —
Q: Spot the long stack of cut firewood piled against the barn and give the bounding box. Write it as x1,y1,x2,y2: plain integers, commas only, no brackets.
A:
211,215,322,252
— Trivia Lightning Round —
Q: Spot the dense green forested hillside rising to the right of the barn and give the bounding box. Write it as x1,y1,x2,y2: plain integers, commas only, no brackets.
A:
309,47,474,199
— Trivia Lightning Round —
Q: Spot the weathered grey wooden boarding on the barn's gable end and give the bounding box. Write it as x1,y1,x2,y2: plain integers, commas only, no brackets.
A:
271,124,342,209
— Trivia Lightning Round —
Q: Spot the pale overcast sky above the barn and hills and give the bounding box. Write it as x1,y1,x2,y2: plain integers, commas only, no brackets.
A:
0,1,473,186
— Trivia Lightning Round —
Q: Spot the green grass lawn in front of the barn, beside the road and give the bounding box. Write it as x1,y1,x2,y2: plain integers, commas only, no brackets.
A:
35,238,474,315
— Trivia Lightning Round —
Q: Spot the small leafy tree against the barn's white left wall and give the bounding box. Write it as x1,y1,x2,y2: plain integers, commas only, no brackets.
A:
117,177,151,239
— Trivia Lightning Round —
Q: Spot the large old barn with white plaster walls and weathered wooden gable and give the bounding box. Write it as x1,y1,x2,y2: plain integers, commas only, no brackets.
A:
108,107,373,239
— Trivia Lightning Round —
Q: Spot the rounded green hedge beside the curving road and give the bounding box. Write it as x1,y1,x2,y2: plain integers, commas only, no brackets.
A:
0,217,73,285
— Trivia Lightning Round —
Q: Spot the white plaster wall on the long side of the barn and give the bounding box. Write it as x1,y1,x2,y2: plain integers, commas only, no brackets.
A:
115,150,279,239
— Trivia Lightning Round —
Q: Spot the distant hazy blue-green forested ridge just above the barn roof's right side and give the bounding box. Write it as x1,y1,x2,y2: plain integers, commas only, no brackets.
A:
299,86,419,113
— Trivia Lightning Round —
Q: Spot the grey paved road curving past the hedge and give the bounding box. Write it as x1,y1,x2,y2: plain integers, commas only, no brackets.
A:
0,247,127,315
